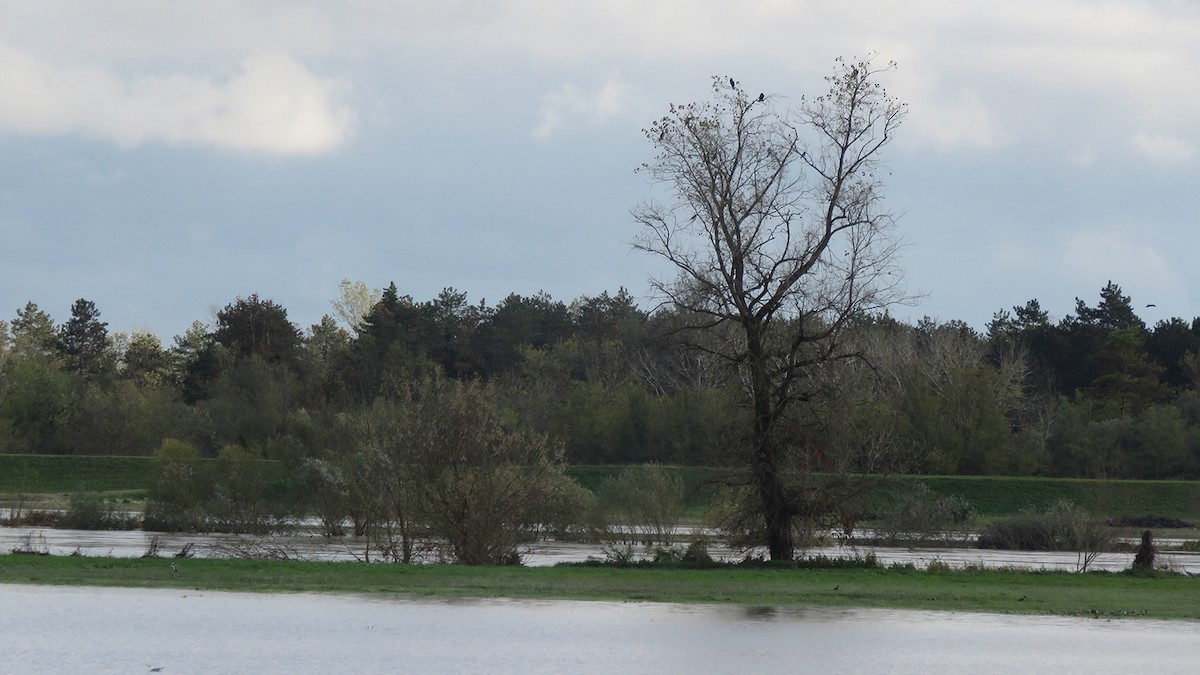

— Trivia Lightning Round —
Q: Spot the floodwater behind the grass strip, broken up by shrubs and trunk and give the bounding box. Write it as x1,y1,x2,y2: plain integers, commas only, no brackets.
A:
0,527,1200,574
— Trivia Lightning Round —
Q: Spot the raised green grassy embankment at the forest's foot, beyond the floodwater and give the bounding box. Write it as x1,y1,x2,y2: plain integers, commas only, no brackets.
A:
7,455,1200,520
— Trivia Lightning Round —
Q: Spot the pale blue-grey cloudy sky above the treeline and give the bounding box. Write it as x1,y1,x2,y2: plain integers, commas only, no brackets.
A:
0,0,1200,339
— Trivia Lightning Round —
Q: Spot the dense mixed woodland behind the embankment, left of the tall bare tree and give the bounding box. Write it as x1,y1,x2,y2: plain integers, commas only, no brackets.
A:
0,286,730,464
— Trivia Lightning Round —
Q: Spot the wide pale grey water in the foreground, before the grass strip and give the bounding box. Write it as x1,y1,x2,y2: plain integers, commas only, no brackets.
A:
0,585,1200,675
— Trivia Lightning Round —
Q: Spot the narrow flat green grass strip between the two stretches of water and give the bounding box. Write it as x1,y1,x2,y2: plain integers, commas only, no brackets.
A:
0,555,1200,620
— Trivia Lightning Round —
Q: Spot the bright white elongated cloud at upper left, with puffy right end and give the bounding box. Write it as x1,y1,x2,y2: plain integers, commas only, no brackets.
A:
0,46,354,155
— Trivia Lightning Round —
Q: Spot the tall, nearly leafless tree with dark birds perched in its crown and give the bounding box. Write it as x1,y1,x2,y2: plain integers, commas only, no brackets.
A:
632,59,906,560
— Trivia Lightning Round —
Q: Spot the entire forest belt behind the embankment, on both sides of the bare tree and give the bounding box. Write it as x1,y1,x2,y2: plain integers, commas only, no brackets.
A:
0,273,1200,478
